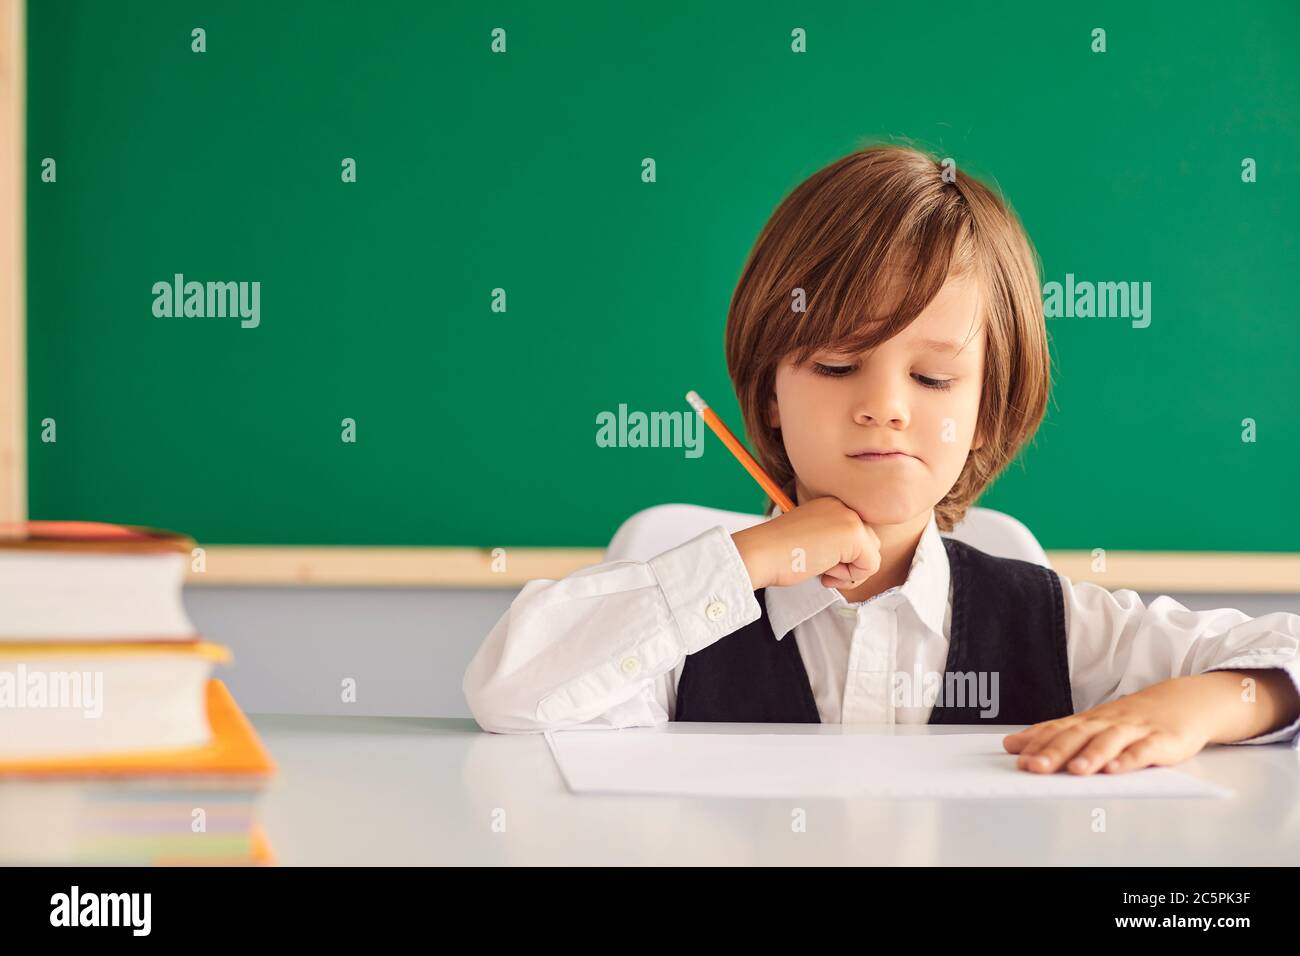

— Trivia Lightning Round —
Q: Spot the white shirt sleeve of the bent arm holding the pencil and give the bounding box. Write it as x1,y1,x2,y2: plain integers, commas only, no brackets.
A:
462,525,761,734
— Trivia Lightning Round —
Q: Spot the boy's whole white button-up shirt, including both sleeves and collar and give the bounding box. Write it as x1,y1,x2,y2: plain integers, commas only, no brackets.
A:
463,509,1300,748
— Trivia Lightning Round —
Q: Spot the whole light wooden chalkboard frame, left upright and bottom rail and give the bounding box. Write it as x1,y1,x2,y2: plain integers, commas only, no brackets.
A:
0,0,1300,593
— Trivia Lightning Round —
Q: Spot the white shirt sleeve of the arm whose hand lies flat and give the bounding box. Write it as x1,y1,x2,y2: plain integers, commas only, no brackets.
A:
1060,576,1300,748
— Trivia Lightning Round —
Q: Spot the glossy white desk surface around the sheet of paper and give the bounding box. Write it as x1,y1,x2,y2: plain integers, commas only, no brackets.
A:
251,714,1300,866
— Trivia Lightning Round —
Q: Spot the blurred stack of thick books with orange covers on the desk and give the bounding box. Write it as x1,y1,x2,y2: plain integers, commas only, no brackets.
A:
0,522,274,865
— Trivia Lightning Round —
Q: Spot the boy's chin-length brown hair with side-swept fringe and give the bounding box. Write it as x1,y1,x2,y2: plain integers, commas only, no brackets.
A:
725,146,1050,531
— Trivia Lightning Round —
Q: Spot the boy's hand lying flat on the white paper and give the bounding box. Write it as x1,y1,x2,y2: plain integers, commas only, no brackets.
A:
1002,678,1212,774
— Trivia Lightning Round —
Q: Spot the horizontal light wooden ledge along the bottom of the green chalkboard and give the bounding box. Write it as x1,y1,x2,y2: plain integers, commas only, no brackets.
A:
180,545,1300,594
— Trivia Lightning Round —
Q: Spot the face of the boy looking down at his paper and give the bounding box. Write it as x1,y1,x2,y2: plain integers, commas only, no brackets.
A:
768,270,984,525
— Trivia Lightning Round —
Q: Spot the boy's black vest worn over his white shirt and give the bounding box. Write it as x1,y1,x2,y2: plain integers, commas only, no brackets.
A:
672,537,1074,724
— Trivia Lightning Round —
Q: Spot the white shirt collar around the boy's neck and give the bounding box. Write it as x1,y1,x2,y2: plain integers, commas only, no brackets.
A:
764,509,950,640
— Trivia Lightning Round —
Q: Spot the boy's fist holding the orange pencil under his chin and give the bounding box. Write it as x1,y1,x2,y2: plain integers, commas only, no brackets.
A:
732,497,880,591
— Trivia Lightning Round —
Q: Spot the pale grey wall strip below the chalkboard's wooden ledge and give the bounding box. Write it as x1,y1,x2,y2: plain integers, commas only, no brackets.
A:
185,587,1300,717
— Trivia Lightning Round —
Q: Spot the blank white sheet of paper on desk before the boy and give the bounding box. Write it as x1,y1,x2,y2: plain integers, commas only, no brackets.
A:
546,727,1232,799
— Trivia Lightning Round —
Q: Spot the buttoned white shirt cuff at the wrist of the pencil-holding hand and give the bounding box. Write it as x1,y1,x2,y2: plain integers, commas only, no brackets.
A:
647,525,762,654
